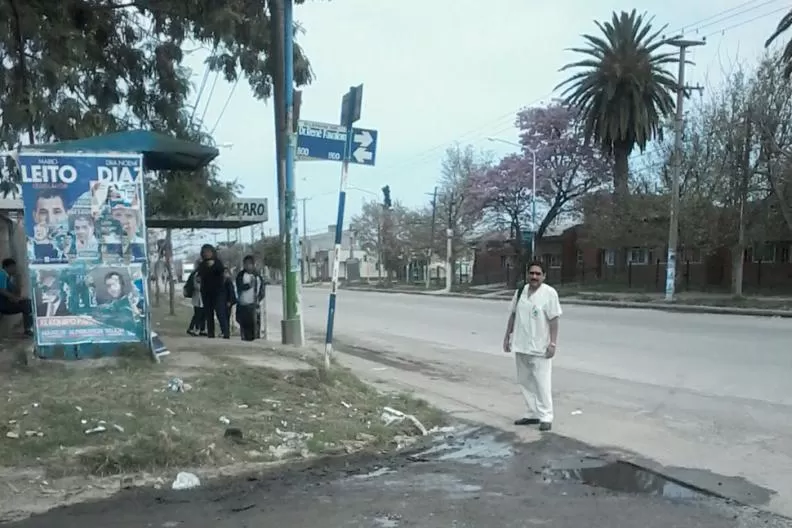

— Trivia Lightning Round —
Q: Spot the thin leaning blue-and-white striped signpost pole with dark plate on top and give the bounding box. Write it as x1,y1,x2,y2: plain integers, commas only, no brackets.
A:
324,85,363,370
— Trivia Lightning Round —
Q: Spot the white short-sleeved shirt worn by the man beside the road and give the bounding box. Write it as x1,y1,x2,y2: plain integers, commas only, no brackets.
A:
509,284,563,356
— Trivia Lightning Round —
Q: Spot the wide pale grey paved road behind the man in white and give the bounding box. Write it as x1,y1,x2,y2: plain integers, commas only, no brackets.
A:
269,288,792,516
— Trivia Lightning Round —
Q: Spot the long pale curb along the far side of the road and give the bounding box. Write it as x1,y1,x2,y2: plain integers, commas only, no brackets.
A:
344,287,792,319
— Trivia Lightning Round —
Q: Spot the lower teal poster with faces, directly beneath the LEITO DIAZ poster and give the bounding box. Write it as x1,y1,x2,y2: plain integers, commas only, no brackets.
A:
31,263,148,346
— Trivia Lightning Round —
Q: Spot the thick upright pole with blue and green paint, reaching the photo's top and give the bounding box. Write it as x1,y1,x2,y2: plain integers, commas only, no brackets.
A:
281,0,303,346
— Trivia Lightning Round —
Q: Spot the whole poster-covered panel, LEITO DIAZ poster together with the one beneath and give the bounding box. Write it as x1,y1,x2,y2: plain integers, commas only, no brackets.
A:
18,152,148,346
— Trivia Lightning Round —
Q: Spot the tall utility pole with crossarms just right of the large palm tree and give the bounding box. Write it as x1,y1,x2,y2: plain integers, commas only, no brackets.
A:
665,37,706,302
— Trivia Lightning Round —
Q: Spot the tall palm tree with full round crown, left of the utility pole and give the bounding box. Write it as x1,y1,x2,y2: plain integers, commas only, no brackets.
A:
557,10,678,197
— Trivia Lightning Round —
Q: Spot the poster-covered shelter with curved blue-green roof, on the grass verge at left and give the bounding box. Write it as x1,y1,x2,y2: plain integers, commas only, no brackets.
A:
18,130,219,359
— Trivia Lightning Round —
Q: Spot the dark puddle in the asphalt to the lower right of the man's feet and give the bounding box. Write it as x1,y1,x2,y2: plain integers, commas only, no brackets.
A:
544,458,707,500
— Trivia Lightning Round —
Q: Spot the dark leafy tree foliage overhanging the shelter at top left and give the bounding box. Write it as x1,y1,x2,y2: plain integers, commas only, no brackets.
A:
0,0,312,200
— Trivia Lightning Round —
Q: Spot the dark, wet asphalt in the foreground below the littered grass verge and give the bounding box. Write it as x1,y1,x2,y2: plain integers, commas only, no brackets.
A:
8,429,787,528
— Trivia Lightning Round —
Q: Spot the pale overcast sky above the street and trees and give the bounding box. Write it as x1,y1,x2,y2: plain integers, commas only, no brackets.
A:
188,0,792,245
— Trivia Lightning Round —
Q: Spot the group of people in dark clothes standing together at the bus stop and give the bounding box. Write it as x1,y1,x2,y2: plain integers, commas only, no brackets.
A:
184,244,266,341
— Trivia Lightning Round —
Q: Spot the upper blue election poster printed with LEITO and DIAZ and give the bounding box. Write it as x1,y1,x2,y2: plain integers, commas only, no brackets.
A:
19,152,146,264
